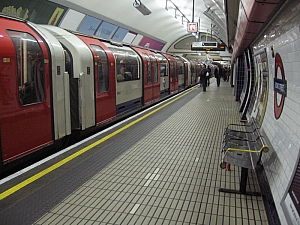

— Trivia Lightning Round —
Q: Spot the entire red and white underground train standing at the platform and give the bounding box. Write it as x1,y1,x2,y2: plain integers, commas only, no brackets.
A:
0,15,199,171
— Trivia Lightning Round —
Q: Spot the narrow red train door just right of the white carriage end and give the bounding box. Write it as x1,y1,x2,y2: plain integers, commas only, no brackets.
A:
78,35,116,124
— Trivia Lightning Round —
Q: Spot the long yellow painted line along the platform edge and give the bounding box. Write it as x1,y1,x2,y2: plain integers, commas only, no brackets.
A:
0,88,194,200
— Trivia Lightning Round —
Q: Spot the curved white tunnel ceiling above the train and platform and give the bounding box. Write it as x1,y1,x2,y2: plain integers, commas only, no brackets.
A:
52,0,227,51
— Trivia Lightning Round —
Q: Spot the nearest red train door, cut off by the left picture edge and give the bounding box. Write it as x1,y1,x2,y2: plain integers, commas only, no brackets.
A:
0,18,53,163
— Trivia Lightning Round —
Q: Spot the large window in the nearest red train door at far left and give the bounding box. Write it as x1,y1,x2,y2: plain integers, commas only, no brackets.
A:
7,30,45,105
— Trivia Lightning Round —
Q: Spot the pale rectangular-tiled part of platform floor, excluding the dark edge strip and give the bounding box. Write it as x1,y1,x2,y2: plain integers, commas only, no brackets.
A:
32,83,268,225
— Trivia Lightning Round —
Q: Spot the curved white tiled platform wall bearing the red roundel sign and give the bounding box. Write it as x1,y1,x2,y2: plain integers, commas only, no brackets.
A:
252,1,300,225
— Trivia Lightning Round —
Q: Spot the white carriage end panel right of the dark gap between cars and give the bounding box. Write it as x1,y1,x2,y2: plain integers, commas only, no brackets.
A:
41,25,96,130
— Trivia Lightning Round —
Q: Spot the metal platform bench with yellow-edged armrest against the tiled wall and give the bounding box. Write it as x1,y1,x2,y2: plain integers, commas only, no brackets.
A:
219,118,269,196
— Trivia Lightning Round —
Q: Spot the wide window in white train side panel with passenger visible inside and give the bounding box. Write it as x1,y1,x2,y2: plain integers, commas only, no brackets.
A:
110,47,140,82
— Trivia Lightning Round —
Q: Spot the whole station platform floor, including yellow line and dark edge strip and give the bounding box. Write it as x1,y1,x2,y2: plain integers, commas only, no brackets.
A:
0,79,268,225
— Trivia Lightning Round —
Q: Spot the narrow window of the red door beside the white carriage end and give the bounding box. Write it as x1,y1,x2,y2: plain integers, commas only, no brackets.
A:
91,45,109,93
